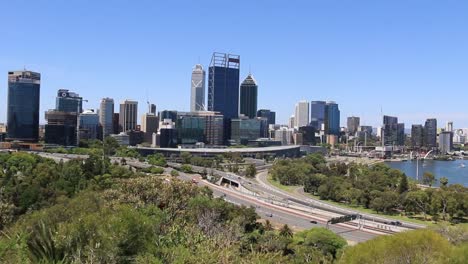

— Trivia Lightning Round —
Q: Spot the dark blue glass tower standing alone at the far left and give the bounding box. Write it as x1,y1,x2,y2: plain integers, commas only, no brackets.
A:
6,71,41,142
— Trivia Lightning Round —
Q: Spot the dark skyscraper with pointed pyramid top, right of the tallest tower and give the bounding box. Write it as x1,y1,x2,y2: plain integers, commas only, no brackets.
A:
240,74,258,119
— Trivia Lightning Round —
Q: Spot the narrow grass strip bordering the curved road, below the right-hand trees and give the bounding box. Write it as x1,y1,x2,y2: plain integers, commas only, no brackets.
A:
267,174,434,226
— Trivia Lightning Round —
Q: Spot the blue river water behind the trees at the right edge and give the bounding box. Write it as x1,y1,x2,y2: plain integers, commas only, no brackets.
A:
385,160,468,187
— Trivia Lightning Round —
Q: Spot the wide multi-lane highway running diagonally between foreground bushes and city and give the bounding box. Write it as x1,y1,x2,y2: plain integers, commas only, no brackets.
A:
36,153,404,242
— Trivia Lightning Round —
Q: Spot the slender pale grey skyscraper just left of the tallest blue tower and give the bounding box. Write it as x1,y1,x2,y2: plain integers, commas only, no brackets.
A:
190,64,206,112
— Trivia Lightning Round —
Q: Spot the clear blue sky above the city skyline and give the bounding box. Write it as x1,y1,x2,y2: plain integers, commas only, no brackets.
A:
0,0,468,128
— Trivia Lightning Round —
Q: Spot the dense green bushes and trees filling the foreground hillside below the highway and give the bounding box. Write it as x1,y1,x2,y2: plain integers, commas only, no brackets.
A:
0,153,468,264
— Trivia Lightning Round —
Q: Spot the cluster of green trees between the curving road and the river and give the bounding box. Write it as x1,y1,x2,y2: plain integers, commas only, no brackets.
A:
270,154,468,222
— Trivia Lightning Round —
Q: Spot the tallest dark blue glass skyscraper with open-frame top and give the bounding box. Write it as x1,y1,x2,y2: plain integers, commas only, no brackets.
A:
208,52,240,142
